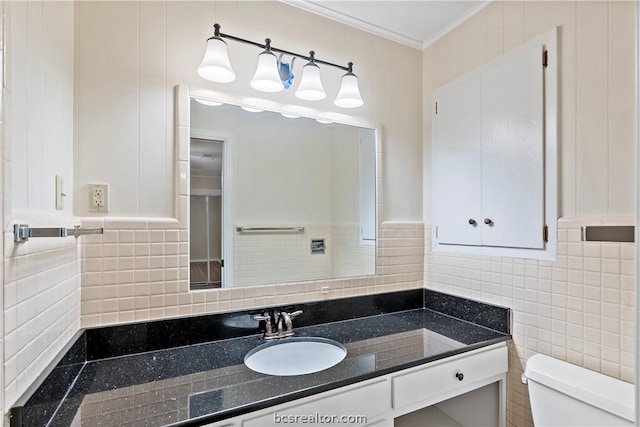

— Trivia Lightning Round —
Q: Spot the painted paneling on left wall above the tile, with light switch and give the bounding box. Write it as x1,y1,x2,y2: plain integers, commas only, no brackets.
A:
4,1,74,217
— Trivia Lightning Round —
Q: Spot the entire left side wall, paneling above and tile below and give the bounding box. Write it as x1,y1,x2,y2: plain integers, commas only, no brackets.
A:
2,1,81,409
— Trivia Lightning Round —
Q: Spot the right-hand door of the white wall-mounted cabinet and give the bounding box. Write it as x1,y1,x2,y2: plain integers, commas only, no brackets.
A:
481,41,544,249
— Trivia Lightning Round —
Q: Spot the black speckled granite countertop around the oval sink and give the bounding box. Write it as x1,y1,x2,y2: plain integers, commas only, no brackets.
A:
12,293,510,427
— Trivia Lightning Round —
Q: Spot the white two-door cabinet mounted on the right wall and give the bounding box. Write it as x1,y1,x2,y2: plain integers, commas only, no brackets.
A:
432,29,557,259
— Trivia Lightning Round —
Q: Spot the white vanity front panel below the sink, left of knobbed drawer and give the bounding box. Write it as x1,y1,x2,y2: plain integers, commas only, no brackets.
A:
242,379,391,427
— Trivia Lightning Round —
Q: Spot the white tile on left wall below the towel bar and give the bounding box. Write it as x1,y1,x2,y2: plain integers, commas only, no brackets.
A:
3,236,81,408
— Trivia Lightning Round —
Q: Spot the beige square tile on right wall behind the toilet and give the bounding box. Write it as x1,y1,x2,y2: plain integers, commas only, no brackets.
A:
424,217,635,427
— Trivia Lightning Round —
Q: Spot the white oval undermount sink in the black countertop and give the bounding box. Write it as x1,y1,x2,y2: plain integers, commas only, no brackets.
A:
244,337,347,376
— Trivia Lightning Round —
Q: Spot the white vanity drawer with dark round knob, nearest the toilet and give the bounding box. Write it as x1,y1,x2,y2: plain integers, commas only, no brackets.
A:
392,346,508,409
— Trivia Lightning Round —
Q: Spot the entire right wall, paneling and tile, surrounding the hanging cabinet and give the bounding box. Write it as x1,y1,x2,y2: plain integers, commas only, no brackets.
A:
423,1,637,427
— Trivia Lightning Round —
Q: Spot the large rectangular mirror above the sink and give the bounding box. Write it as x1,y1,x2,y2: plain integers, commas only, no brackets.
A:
189,99,377,289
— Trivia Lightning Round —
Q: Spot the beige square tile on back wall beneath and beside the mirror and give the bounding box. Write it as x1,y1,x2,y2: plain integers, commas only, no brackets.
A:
82,218,424,327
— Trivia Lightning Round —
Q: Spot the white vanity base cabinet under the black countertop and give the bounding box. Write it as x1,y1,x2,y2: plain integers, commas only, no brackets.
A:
202,343,507,427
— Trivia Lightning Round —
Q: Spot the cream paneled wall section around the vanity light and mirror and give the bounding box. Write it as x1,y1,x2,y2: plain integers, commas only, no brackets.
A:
76,1,422,221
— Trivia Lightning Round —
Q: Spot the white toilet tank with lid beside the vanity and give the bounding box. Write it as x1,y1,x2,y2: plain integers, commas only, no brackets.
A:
522,354,635,427
